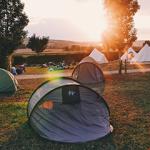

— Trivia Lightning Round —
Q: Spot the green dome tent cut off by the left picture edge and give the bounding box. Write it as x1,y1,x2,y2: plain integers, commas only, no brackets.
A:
0,68,18,96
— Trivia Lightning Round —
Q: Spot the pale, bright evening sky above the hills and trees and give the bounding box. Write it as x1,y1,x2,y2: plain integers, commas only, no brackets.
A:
22,0,150,41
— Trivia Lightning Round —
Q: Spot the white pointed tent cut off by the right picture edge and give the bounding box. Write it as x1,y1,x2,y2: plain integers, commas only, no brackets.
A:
131,44,150,63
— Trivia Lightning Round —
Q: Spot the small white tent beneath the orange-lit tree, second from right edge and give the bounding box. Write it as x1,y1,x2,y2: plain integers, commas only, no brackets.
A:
121,47,137,62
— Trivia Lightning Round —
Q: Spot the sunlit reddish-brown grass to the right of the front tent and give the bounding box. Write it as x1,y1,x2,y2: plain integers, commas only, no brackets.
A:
104,73,150,150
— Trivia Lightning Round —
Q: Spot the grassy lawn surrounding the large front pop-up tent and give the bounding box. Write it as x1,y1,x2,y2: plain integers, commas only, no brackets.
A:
0,73,150,150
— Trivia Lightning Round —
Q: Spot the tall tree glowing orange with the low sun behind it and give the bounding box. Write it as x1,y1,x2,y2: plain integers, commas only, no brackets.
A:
103,0,140,51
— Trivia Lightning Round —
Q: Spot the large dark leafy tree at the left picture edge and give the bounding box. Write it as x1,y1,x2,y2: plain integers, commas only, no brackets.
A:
0,0,29,69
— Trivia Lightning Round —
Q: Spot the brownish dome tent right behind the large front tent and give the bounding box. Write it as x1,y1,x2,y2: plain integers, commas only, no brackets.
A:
72,56,105,94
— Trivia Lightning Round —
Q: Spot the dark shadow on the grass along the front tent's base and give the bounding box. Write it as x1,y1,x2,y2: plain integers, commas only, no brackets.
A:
0,122,117,150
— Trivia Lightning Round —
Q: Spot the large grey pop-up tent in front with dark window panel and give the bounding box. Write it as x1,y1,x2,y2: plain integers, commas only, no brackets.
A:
27,77,111,143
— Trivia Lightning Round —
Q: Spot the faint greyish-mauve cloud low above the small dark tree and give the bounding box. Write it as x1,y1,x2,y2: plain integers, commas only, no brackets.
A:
26,18,86,41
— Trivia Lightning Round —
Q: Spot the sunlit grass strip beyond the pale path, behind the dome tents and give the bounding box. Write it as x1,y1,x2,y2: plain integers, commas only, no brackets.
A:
24,61,150,74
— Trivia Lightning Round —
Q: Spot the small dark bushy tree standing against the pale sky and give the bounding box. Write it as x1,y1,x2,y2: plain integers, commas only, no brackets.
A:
27,34,49,53
